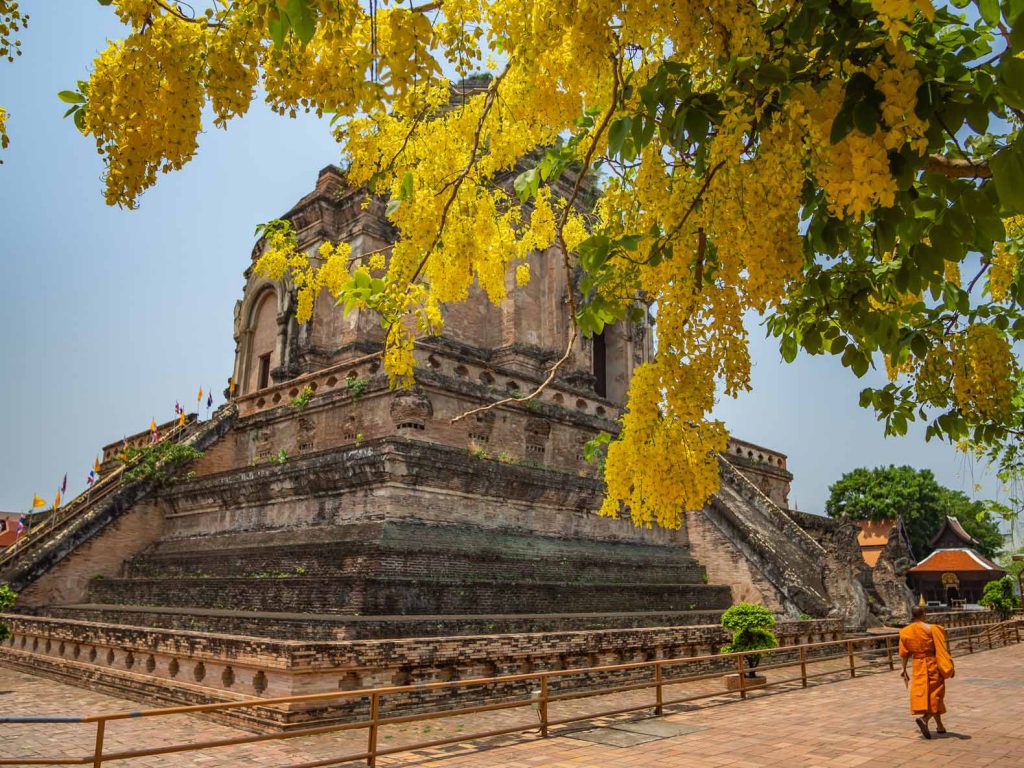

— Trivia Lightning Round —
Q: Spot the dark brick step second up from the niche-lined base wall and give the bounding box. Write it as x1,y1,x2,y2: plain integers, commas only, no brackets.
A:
89,577,730,615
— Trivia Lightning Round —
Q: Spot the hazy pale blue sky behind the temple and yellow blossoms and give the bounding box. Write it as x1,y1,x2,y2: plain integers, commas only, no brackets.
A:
0,0,998,512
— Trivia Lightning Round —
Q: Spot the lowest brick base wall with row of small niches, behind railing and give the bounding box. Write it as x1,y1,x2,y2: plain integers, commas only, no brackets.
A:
0,616,842,730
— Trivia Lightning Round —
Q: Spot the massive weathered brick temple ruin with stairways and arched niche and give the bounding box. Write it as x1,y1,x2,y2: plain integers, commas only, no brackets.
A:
0,157,906,729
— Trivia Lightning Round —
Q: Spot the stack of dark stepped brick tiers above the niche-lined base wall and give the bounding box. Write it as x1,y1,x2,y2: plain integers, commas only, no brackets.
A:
36,521,730,639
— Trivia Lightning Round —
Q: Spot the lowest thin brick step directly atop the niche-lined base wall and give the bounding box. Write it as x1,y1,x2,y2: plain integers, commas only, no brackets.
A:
41,603,722,641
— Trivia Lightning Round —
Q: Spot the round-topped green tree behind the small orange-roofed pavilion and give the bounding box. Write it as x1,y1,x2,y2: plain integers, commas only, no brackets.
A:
825,465,1002,559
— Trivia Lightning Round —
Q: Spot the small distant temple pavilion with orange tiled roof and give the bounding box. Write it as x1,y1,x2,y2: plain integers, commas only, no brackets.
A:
908,516,1007,605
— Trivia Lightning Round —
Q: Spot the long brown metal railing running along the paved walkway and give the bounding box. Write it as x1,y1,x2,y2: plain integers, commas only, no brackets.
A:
0,618,1022,768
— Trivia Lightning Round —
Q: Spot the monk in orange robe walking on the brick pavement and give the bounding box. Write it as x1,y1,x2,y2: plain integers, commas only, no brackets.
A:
899,605,954,738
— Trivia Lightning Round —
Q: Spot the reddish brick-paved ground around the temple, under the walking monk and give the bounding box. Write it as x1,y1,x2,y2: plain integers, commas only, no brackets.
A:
0,645,1024,768
